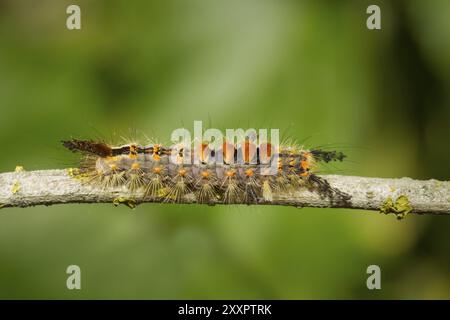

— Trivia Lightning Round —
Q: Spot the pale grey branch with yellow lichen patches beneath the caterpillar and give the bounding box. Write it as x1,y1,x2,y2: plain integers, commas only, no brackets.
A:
0,170,450,218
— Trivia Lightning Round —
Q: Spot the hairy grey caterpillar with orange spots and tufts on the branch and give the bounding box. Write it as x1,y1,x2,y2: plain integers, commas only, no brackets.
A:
62,139,350,204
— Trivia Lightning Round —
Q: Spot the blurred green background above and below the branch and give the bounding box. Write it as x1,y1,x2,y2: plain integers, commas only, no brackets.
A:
0,0,450,299
